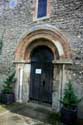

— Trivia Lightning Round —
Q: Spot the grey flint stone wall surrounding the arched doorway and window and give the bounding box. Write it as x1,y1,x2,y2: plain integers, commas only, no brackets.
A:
0,0,83,114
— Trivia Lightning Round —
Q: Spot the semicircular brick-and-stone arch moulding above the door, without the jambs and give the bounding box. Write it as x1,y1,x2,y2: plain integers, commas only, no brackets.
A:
15,25,72,61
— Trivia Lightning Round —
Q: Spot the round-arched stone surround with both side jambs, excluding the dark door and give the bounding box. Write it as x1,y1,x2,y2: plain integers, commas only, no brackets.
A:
15,24,72,111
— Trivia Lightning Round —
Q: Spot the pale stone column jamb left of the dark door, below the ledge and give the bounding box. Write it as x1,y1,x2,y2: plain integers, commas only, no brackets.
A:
15,63,31,102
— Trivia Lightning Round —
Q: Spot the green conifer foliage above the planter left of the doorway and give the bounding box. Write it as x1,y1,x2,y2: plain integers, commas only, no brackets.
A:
2,72,16,94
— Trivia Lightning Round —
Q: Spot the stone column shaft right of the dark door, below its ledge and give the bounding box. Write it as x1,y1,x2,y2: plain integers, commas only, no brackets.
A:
52,64,66,112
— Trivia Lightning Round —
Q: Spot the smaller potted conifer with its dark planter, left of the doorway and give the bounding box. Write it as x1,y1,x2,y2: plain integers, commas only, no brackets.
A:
1,72,16,104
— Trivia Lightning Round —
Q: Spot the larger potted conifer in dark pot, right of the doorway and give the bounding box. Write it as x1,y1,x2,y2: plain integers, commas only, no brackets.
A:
60,81,82,125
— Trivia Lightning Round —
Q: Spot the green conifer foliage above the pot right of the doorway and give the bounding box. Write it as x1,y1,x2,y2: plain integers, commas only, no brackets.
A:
60,81,82,108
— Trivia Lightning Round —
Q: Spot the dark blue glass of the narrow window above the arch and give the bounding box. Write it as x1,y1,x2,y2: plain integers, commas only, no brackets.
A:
37,0,47,18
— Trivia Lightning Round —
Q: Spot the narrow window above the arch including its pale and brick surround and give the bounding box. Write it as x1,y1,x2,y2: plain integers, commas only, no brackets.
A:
33,0,52,21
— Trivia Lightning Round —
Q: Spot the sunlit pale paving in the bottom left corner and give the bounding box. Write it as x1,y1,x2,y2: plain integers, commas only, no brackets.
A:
0,112,48,125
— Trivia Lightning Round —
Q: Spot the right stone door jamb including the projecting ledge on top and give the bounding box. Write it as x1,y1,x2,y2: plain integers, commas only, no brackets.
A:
52,60,72,112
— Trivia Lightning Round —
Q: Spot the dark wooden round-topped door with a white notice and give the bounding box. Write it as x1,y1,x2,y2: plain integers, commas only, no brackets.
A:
30,46,53,103
